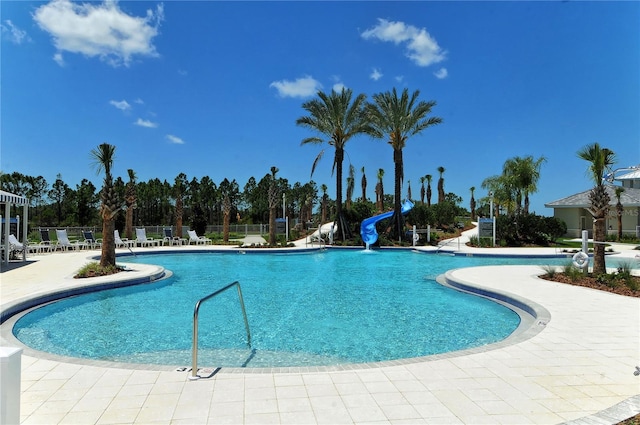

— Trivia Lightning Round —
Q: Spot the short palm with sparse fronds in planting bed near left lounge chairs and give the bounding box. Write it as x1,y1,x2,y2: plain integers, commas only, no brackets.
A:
91,143,122,267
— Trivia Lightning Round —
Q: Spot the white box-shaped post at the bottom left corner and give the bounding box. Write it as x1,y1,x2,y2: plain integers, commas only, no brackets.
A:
0,347,22,425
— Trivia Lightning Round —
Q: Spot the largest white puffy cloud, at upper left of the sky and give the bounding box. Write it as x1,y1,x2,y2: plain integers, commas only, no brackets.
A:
33,0,164,67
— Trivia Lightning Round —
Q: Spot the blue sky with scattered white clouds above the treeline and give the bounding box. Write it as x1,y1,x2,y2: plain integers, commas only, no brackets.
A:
0,0,640,215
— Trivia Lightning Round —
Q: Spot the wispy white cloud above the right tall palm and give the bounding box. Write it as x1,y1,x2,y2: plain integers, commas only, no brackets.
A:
360,18,446,66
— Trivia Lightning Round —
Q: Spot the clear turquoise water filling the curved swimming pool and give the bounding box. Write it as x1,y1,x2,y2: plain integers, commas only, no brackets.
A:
14,250,567,367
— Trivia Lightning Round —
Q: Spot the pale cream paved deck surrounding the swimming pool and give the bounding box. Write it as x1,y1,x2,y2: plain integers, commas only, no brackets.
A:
0,240,640,424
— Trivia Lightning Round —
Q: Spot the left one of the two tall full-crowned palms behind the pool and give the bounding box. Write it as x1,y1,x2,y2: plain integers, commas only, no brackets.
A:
296,88,373,240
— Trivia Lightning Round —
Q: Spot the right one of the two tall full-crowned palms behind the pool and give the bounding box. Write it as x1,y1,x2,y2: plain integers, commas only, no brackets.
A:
367,87,442,240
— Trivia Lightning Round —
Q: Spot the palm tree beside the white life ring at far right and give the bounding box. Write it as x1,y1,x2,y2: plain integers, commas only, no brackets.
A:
578,142,615,276
